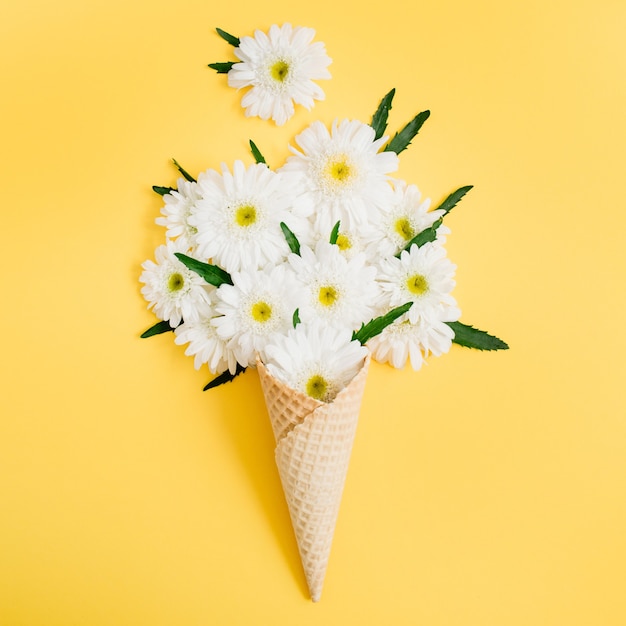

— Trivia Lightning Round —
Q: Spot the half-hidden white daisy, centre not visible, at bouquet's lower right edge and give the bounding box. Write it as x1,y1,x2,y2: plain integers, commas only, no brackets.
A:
367,316,454,370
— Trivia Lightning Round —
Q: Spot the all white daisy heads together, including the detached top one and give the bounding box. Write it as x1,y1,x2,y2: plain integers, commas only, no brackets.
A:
140,25,460,401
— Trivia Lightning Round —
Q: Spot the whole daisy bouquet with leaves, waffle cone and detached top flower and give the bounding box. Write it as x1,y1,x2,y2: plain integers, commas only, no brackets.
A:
140,24,508,601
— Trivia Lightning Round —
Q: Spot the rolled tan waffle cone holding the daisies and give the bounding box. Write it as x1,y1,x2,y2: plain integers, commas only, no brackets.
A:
257,356,370,602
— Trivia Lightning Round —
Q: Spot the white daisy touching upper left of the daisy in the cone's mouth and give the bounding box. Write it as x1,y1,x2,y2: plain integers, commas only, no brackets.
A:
212,264,300,367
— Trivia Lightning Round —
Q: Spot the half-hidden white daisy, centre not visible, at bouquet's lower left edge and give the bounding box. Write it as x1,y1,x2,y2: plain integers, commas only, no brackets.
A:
174,302,237,374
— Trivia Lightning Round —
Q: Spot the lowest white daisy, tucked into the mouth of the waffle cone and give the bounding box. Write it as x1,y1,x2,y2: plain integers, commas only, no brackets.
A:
263,323,368,402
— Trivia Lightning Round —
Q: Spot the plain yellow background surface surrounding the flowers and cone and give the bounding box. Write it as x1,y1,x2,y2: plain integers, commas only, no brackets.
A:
0,0,626,626
